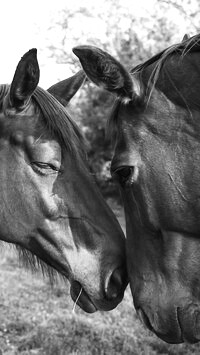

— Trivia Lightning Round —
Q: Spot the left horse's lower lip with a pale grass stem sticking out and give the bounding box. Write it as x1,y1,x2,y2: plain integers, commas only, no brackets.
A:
70,281,98,313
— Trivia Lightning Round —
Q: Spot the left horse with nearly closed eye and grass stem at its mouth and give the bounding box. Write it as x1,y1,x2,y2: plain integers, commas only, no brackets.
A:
0,48,127,313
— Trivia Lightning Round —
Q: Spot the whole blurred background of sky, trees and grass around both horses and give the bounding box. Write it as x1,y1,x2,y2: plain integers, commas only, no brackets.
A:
0,0,200,355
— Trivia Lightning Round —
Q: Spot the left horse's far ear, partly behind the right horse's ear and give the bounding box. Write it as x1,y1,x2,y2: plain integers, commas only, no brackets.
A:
47,70,86,106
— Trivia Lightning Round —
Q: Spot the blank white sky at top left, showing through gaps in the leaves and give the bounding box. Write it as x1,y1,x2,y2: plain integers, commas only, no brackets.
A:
0,0,193,88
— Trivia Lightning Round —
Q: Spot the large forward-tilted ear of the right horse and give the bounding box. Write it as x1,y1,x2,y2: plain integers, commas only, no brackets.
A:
73,46,140,100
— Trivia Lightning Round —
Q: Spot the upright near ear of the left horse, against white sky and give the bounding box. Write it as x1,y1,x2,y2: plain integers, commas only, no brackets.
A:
9,48,40,109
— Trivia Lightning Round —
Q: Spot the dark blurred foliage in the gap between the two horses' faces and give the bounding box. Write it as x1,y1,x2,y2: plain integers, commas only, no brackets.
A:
69,84,116,195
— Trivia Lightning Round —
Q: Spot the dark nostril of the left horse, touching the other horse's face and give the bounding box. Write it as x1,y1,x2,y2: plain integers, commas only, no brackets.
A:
105,268,126,300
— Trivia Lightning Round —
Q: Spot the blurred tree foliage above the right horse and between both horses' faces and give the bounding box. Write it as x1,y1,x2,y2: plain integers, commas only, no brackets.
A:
45,0,200,196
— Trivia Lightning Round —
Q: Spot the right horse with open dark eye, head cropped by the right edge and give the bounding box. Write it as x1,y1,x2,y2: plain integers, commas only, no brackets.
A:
73,34,200,344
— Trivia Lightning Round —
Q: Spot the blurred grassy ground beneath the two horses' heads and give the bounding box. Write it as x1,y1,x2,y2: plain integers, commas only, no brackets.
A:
0,202,200,355
